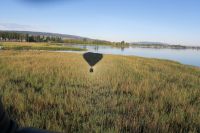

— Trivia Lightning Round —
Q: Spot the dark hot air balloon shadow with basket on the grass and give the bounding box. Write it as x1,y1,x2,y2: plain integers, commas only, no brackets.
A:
83,52,103,73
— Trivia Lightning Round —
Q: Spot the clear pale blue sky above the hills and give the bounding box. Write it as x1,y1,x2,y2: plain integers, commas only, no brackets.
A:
0,0,200,46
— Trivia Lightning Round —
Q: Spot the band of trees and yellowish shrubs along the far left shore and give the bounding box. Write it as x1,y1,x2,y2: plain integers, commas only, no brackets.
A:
0,31,129,47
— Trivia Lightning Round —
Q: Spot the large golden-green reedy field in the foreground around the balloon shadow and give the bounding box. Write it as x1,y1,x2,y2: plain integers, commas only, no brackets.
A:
0,51,200,133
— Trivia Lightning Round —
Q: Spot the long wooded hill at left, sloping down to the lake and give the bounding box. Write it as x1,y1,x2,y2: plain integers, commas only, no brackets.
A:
0,30,119,46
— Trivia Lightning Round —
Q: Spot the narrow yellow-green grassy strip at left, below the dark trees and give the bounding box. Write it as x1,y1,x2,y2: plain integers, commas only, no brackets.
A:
0,42,86,51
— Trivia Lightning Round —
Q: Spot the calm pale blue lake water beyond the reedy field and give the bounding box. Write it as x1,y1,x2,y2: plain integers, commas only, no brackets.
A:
67,45,200,67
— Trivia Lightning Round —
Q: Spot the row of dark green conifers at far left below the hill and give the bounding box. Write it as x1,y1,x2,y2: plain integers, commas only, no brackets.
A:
0,32,63,42
